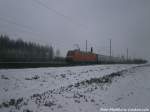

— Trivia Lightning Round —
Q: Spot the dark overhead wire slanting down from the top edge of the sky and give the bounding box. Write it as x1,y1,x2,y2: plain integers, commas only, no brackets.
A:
32,0,87,28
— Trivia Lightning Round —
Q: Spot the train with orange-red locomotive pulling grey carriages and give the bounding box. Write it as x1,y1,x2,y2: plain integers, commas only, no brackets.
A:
66,49,123,64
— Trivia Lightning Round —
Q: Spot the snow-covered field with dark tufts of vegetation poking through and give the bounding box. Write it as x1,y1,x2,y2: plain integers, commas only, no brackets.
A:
0,65,150,112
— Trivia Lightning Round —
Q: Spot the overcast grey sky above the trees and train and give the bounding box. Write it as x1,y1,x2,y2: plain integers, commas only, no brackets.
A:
0,0,150,60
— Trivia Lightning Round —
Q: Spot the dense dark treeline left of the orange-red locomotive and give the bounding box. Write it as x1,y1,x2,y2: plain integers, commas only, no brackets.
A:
0,35,54,62
